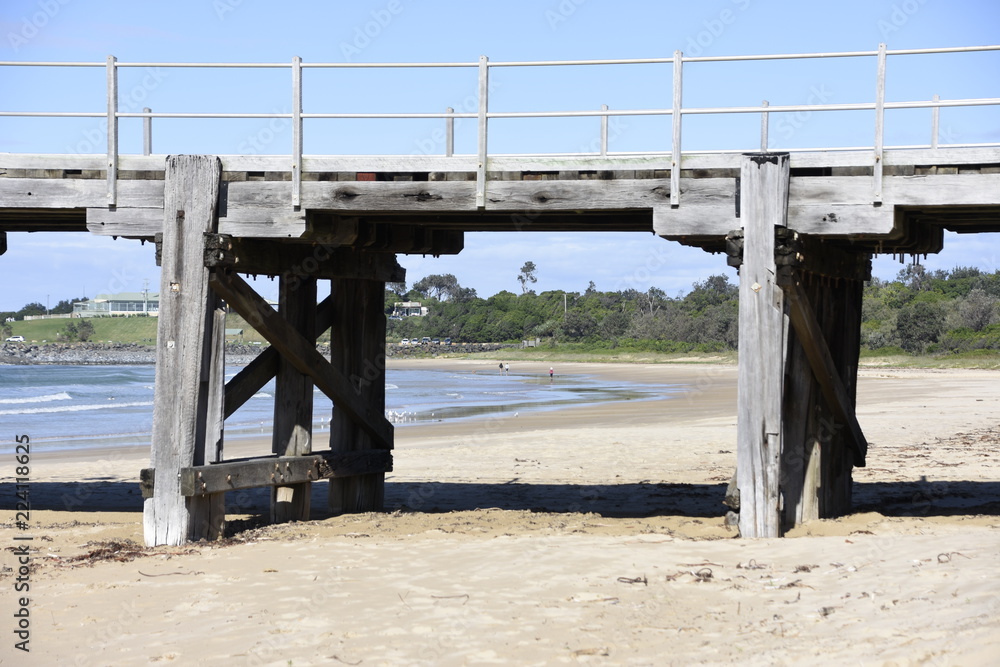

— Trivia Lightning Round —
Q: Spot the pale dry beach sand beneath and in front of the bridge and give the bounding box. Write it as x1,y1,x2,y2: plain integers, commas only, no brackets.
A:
0,360,1000,665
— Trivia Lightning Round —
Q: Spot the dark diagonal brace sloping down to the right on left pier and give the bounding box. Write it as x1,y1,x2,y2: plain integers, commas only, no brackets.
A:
209,271,392,449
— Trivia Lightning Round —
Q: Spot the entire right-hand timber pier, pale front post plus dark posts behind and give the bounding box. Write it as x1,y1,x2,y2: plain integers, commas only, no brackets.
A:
727,153,871,537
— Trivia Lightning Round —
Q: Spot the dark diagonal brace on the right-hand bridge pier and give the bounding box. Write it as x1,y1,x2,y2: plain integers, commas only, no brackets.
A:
782,278,868,468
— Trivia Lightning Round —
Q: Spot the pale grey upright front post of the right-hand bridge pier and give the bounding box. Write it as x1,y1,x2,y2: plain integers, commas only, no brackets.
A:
736,153,789,537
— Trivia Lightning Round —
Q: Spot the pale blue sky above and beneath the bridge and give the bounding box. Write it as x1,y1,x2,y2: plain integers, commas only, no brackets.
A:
0,0,1000,310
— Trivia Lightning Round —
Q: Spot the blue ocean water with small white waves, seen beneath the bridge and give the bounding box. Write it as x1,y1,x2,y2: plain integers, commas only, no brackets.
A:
0,366,684,452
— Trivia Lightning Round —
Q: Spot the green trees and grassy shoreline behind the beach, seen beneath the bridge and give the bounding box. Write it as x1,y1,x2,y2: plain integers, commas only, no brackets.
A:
0,262,1000,355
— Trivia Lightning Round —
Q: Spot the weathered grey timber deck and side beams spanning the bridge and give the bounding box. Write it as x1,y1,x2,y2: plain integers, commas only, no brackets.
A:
0,148,1000,254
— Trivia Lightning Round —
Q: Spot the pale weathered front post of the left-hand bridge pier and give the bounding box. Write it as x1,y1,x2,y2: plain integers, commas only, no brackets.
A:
143,155,222,546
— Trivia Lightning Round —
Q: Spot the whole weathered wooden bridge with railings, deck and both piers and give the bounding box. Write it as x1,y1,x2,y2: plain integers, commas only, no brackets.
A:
0,45,1000,545
